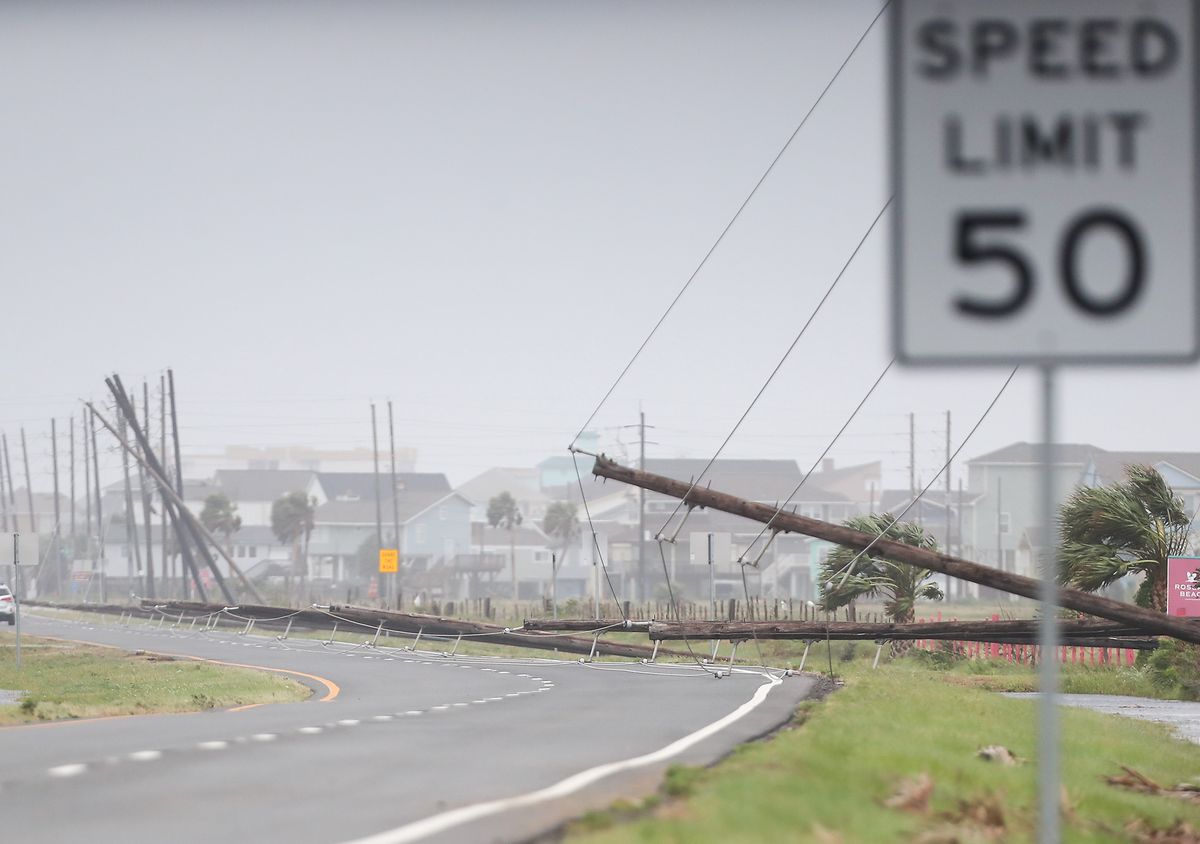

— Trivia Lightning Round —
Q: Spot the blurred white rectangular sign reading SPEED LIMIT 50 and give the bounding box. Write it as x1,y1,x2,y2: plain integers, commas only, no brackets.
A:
890,0,1200,364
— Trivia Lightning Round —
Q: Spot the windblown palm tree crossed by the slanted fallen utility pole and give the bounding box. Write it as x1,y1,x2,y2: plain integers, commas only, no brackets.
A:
821,513,944,629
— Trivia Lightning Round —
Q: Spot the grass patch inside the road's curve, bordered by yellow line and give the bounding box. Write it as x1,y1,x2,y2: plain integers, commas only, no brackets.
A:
0,633,310,725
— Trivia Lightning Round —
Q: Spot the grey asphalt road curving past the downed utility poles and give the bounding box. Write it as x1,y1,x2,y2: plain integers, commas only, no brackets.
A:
0,613,816,844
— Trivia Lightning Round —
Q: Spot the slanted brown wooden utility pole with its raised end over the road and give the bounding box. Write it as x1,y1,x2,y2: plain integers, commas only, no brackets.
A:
592,455,1200,644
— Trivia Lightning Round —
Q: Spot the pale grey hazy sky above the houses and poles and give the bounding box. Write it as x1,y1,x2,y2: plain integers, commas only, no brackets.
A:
0,0,1200,489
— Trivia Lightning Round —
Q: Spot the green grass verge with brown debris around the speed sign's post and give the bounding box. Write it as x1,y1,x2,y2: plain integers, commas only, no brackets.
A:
569,660,1200,844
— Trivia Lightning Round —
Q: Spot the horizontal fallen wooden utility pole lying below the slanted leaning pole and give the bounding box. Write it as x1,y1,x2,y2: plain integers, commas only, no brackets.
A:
649,619,1158,651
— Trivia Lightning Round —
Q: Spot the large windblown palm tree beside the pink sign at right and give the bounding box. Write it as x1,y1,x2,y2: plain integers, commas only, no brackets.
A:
1058,466,1192,612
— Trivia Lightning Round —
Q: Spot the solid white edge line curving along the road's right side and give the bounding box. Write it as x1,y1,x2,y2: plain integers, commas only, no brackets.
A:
343,675,784,844
